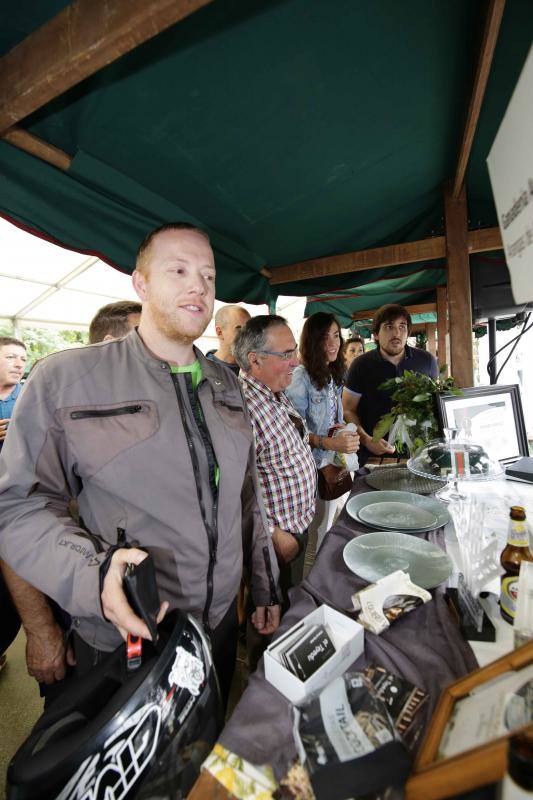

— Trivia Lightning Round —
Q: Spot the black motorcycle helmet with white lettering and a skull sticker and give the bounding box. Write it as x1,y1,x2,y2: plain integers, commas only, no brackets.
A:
7,612,223,800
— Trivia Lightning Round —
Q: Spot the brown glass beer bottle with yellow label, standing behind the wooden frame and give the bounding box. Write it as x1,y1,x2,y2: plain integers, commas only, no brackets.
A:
500,506,533,625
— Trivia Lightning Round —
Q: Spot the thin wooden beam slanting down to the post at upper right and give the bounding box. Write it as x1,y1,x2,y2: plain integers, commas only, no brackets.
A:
452,0,505,200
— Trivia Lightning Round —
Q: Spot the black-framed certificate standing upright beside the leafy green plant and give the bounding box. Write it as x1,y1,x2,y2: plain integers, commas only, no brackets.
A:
437,384,529,464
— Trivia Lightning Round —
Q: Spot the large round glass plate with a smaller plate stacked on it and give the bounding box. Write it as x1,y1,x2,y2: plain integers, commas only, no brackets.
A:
346,491,450,533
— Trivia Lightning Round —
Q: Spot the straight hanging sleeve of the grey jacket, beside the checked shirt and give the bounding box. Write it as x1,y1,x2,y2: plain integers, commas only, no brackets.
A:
237,396,281,606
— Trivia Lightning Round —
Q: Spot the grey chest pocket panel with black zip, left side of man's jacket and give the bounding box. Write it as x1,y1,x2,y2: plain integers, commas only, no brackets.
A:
59,400,159,478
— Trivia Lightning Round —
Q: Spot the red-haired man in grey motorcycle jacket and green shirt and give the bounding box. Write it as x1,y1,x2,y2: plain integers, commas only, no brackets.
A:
0,223,279,704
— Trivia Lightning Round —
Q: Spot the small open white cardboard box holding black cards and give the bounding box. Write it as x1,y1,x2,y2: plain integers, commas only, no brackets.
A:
265,605,364,705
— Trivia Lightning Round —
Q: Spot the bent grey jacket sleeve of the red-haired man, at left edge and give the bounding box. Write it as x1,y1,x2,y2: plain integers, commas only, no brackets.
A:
0,364,109,619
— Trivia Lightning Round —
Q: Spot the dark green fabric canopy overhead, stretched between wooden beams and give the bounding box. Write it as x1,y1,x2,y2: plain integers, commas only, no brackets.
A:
0,0,533,306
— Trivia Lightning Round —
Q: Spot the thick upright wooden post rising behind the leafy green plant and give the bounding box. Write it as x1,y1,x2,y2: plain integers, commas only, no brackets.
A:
444,185,474,387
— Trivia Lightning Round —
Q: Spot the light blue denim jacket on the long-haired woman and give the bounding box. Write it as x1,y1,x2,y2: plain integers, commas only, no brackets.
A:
285,365,344,467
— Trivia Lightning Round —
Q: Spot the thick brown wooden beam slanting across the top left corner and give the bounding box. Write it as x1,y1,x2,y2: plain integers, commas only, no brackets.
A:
0,0,211,133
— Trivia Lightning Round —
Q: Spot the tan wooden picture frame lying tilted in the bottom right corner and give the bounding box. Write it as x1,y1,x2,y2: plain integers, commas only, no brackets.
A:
405,641,533,800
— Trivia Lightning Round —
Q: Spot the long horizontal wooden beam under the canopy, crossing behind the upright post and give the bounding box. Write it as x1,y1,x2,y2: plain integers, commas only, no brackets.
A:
270,228,502,286
